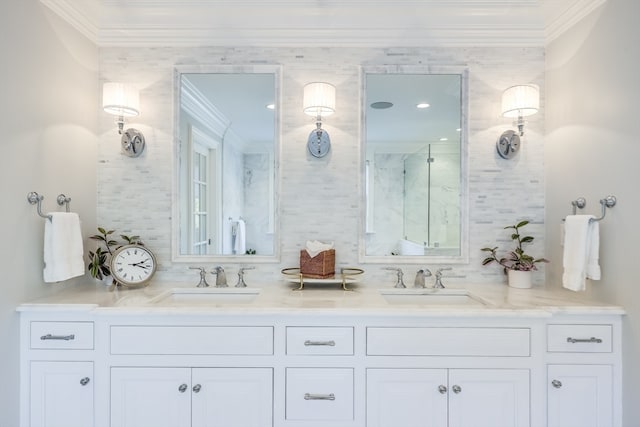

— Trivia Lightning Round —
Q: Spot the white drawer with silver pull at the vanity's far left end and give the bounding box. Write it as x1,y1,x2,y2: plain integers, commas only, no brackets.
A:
31,322,93,350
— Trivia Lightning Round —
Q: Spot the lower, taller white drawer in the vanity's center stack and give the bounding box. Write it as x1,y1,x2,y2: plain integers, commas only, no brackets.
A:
286,368,353,421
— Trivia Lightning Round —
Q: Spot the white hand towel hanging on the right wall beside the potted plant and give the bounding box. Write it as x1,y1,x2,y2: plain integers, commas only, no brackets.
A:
562,215,600,291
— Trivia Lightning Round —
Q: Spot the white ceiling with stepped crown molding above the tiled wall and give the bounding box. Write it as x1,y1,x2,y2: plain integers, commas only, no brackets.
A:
40,0,606,47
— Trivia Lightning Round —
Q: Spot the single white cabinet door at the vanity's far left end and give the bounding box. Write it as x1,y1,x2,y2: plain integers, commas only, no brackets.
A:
29,362,93,427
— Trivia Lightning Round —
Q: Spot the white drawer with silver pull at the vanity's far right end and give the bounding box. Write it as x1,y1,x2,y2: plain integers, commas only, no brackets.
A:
547,325,612,353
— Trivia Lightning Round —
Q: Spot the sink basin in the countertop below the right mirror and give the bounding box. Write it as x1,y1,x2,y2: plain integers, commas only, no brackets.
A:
379,289,485,306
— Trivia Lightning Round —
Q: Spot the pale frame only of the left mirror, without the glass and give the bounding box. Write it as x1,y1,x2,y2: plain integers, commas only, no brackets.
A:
171,64,282,264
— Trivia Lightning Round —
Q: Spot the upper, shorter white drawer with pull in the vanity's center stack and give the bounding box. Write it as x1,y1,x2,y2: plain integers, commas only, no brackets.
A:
287,326,353,355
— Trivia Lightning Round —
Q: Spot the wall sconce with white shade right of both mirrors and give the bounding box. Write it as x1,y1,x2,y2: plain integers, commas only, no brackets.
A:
496,84,540,159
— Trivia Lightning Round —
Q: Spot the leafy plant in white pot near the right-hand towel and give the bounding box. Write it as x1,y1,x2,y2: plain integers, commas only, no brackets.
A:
481,220,549,288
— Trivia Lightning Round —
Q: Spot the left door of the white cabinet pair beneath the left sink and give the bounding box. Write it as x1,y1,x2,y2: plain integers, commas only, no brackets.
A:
111,368,191,427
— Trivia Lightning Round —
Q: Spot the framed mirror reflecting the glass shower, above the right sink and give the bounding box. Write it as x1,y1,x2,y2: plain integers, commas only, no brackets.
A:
360,66,468,264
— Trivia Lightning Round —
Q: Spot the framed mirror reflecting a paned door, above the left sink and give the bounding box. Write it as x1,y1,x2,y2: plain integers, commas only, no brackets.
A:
172,66,280,263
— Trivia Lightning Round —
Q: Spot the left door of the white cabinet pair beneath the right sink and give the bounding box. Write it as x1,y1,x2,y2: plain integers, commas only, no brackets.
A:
367,369,448,427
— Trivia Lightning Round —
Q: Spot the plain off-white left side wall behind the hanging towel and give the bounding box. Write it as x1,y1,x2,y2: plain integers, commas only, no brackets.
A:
0,0,98,427
